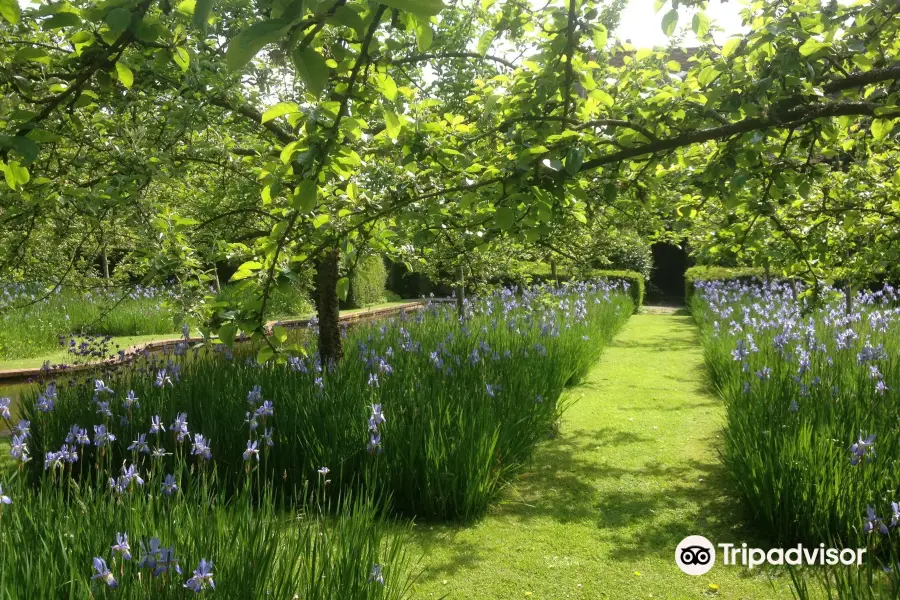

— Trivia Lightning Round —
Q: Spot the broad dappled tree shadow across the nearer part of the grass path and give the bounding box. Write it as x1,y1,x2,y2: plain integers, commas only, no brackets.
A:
416,427,759,580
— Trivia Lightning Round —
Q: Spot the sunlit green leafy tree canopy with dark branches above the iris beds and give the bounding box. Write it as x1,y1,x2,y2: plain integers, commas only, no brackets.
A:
0,0,900,358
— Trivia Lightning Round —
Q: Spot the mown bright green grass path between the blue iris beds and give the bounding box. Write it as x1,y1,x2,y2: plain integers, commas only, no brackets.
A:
413,314,791,599
